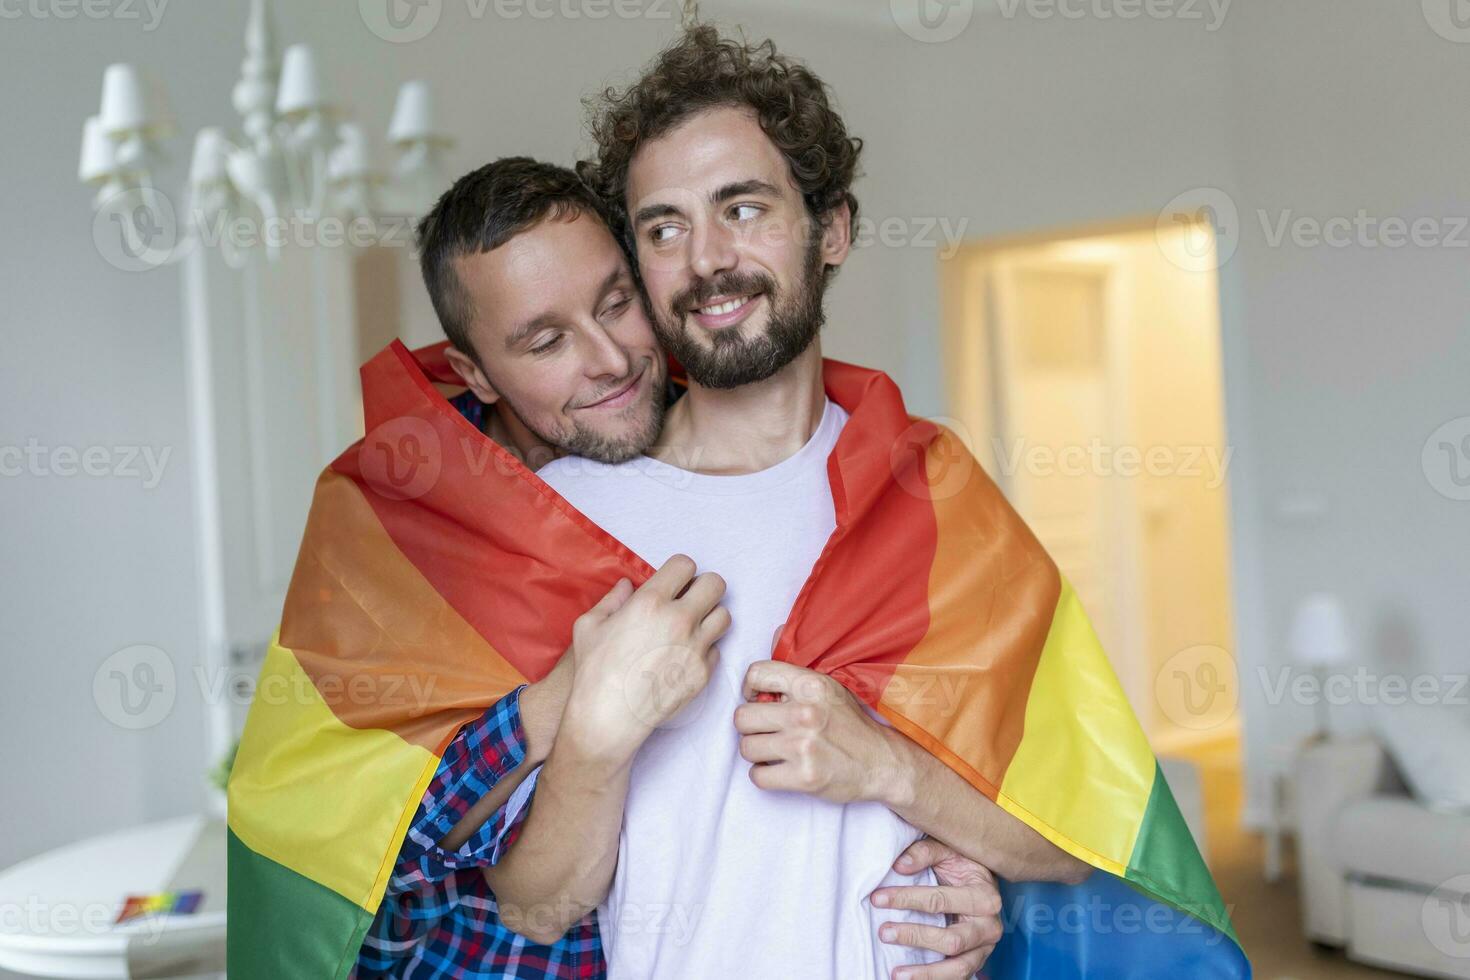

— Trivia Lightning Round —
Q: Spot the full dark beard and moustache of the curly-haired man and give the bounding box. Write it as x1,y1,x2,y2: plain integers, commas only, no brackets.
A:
644,235,826,389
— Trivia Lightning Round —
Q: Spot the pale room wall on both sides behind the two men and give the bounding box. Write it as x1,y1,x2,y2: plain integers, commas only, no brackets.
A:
0,0,1470,865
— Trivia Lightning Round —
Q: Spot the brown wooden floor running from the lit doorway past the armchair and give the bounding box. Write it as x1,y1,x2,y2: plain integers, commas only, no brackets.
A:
1177,739,1405,980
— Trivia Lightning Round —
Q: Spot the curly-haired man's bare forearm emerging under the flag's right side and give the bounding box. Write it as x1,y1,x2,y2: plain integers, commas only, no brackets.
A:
876,729,1092,883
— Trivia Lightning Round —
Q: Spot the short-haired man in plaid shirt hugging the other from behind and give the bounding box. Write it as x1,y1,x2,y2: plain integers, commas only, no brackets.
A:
354,157,1017,980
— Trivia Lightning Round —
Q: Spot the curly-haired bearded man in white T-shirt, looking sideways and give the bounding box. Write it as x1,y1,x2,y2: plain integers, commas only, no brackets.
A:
487,26,1088,980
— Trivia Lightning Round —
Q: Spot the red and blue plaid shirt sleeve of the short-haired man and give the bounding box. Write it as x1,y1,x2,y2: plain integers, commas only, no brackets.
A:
357,685,543,976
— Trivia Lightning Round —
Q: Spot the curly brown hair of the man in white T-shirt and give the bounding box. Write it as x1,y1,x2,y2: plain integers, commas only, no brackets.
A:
578,24,863,258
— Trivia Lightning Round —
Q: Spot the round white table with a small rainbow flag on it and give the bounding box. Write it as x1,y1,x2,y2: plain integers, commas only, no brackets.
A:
0,817,225,980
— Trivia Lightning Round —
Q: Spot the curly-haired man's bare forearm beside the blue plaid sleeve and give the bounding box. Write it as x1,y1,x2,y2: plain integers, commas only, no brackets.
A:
485,717,632,945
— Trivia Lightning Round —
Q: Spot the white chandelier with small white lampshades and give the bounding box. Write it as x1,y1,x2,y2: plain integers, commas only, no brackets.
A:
78,0,451,269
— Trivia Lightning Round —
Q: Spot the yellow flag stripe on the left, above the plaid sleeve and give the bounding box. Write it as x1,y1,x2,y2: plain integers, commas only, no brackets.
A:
229,635,438,912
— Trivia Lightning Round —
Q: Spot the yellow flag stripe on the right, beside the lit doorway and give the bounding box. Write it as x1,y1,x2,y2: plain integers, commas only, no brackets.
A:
998,579,1155,876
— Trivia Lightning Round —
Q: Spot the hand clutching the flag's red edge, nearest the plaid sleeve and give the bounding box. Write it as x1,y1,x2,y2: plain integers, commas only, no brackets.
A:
557,555,731,763
